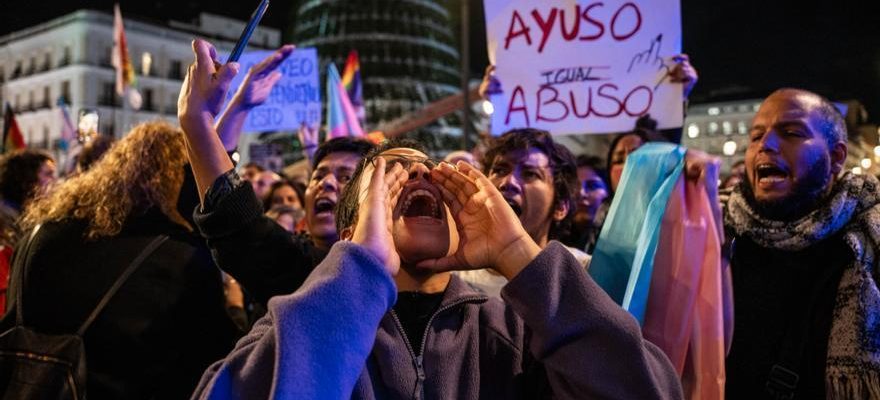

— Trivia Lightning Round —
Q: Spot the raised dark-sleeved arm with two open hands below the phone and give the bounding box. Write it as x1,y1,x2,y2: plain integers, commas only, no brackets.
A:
178,39,323,304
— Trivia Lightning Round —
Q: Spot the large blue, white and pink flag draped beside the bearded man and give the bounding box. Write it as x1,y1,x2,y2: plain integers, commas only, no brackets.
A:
589,143,732,400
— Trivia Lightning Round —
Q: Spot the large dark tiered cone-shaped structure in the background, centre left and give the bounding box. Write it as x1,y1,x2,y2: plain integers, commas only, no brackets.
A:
289,0,461,148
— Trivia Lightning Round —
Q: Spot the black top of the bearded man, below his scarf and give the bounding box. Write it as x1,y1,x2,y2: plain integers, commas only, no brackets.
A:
725,235,853,399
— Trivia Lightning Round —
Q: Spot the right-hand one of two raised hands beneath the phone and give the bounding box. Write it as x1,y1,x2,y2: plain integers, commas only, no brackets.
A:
231,44,295,110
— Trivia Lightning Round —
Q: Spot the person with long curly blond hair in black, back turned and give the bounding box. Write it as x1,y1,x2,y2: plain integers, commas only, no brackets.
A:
0,122,238,398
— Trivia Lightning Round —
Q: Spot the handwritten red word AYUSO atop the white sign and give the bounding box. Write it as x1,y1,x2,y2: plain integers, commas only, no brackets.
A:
504,2,642,53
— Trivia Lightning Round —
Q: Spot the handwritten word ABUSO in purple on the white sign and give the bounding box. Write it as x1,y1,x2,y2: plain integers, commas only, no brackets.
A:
504,83,654,127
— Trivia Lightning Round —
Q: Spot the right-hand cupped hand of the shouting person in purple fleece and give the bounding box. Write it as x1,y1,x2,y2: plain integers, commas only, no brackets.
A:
418,162,541,279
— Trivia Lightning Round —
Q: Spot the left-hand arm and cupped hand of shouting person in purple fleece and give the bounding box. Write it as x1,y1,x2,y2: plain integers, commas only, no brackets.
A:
193,160,406,399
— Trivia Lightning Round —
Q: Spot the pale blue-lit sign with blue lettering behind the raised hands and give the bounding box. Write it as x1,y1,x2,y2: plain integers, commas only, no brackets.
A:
223,48,321,132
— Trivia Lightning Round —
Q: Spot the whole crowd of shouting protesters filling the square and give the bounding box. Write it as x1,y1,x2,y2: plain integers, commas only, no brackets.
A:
0,3,880,399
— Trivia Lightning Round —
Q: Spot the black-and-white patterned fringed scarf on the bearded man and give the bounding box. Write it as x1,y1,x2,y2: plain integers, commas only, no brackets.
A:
724,173,880,399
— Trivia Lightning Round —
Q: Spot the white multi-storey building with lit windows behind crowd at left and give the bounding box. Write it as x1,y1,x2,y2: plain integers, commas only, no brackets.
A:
0,10,281,155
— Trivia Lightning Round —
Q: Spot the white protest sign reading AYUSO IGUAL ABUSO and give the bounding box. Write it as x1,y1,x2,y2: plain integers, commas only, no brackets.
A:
485,0,683,135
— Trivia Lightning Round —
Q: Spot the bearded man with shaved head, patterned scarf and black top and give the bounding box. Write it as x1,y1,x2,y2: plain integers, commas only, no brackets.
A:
725,89,880,398
